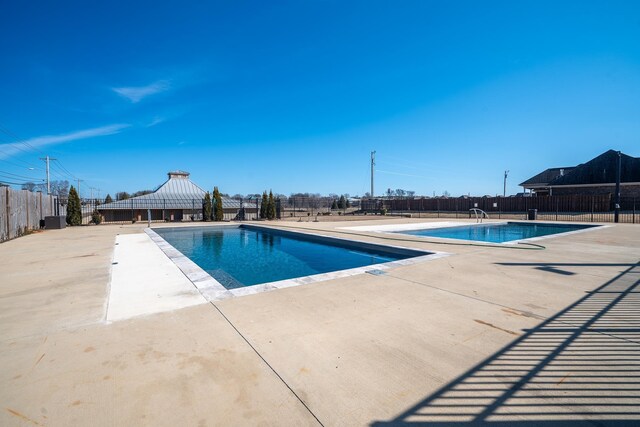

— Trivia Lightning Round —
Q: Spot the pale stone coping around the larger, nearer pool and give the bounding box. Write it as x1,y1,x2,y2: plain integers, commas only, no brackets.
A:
144,224,451,302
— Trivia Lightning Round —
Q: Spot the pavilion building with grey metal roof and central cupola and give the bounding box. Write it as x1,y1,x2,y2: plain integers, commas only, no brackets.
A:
97,171,260,222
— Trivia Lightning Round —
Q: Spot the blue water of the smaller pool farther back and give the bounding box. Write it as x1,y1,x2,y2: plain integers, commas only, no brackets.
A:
396,222,597,243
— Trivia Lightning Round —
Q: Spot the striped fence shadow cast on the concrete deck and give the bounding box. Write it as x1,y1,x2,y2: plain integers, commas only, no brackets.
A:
372,263,640,427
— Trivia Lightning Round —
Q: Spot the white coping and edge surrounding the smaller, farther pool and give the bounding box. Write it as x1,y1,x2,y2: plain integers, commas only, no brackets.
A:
340,220,612,246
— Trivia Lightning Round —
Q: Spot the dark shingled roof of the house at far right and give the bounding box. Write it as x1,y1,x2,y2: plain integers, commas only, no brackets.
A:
520,150,640,187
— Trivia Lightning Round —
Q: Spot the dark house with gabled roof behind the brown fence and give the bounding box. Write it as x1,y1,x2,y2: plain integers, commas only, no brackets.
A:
520,150,640,197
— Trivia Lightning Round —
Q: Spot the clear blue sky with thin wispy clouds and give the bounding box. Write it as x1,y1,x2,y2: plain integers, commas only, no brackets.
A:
0,0,640,197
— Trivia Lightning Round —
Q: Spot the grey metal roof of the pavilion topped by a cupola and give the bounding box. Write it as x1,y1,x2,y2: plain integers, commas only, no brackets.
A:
98,171,246,210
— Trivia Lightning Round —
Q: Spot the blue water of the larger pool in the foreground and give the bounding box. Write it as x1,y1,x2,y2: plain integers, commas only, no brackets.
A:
154,226,426,289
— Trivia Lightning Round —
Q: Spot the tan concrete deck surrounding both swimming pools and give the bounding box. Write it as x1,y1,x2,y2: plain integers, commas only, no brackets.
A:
0,218,640,426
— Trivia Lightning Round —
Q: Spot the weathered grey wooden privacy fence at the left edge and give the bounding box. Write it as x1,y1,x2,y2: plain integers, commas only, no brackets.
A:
0,187,56,242
